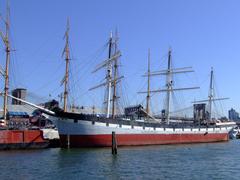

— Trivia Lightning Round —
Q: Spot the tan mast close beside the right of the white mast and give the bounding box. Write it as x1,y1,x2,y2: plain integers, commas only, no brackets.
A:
112,32,118,119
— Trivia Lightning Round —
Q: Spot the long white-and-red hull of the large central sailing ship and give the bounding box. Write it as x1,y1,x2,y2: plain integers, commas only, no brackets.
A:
58,119,230,148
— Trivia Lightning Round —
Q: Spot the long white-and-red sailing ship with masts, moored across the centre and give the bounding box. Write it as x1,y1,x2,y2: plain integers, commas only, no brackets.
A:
42,25,232,148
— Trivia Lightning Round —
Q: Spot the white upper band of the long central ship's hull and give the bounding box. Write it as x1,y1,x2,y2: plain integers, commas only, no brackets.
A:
58,119,232,135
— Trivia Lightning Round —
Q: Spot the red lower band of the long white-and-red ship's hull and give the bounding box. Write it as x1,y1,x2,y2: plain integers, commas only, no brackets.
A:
60,133,229,148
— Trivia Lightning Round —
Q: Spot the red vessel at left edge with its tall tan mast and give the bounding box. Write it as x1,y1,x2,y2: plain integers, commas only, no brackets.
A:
0,5,48,150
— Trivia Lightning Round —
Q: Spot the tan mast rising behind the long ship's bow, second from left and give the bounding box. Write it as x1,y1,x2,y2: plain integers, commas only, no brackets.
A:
63,19,70,112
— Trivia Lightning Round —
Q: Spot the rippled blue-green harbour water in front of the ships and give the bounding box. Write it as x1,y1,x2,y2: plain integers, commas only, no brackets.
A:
0,140,240,180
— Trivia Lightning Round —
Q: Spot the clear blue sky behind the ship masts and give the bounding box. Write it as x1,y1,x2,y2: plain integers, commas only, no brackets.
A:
0,0,240,114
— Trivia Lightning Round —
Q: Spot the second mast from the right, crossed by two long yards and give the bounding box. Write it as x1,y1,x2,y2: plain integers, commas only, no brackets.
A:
166,49,172,124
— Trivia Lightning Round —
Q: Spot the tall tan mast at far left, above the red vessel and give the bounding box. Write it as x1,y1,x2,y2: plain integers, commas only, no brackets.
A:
1,3,10,120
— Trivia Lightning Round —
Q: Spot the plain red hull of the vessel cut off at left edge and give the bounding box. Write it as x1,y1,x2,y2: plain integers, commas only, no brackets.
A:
0,130,49,150
